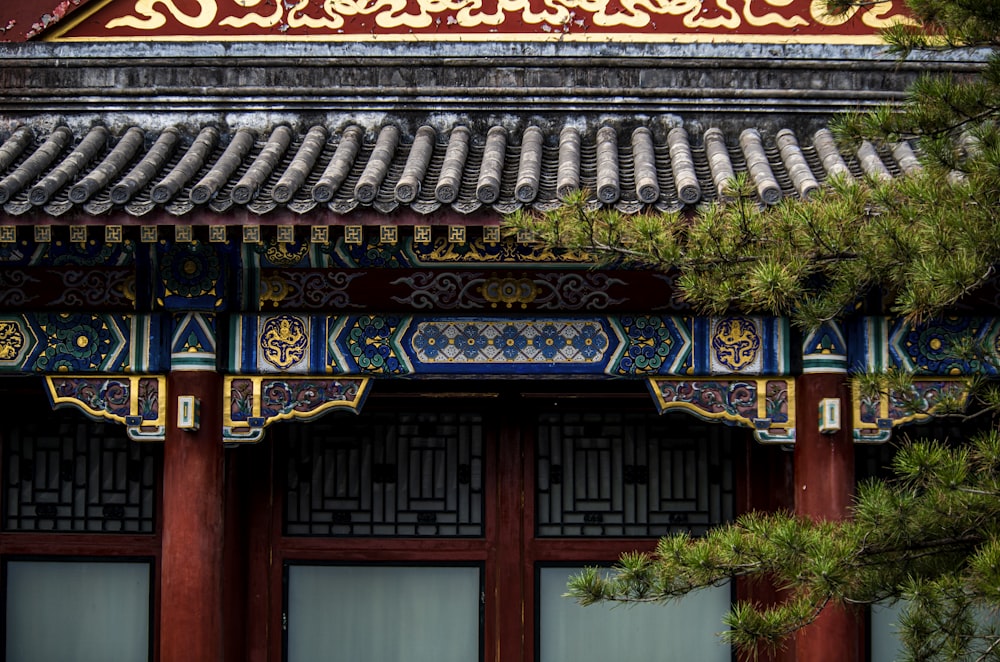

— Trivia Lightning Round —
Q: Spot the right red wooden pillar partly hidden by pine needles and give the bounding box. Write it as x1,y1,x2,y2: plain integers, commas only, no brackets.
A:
795,325,864,662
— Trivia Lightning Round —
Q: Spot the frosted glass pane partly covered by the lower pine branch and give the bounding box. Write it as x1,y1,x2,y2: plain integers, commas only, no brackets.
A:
538,568,731,662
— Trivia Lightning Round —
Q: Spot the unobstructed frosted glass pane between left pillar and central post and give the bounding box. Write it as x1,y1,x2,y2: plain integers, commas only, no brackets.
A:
288,565,480,662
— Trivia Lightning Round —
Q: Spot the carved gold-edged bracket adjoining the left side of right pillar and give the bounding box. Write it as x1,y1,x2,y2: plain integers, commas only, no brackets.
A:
649,377,795,444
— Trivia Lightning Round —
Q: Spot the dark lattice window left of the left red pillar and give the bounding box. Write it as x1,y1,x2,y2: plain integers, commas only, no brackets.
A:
3,421,160,533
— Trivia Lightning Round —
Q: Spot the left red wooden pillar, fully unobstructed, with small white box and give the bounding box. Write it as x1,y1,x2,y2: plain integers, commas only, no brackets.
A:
159,316,224,662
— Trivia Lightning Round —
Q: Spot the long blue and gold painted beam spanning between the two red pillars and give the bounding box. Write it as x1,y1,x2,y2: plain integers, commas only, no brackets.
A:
228,313,790,378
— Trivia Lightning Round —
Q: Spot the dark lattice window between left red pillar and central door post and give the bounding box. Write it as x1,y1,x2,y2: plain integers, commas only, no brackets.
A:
285,412,484,536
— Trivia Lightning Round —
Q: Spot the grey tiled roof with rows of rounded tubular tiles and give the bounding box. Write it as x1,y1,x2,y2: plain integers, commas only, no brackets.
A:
0,124,919,223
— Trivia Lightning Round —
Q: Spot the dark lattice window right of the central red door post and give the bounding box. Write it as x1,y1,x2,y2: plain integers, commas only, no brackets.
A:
536,413,734,537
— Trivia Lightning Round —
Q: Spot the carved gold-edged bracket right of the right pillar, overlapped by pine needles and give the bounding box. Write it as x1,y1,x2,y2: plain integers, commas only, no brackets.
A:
851,377,968,443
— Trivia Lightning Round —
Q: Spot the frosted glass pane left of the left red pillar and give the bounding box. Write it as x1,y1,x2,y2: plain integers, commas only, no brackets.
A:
6,561,149,662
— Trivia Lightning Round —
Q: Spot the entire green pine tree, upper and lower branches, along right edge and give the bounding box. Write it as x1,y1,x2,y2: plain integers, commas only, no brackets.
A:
509,0,1000,660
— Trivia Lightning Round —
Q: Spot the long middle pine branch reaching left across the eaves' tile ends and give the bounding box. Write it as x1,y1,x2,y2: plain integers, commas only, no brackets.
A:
508,163,1000,327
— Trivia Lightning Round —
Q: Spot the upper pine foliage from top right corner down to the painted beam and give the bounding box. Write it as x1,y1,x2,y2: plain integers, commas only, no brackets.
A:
508,0,1000,328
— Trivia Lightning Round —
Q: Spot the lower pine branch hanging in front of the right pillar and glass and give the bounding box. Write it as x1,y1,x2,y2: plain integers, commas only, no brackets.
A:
568,430,1000,660
